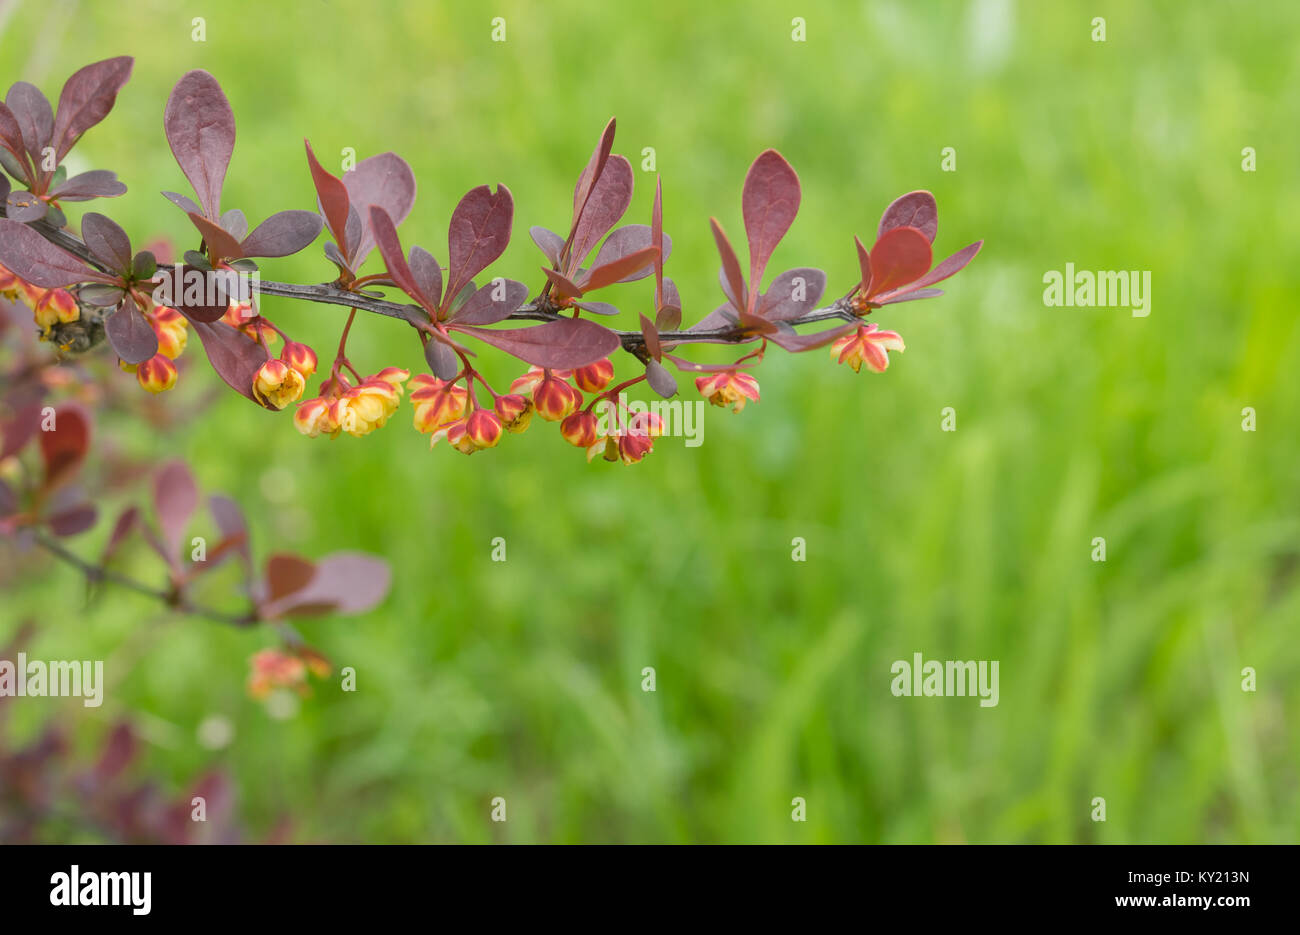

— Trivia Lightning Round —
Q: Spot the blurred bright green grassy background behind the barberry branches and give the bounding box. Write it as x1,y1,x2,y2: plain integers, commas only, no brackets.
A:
0,0,1300,843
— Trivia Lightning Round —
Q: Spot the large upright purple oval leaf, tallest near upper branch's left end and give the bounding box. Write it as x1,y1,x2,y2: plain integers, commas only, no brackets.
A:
163,69,235,218
